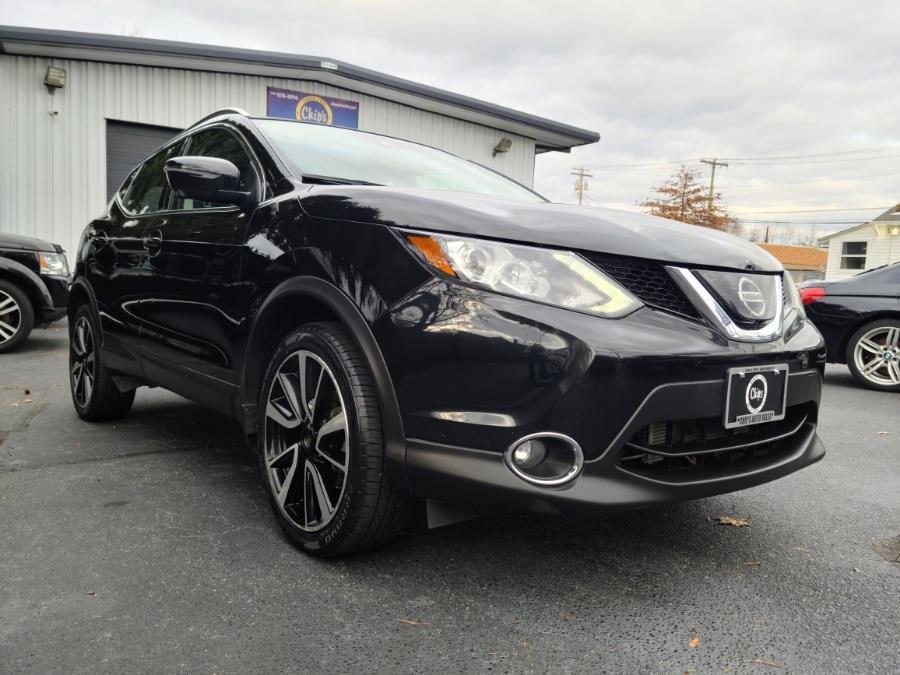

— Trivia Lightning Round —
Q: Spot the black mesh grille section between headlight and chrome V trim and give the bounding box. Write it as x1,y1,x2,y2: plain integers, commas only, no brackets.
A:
585,253,700,319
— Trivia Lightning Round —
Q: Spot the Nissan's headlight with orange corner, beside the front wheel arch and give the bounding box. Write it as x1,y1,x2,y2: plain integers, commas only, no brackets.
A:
404,232,641,318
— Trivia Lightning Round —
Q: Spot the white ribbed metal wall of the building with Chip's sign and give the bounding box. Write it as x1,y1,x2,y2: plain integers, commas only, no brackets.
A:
0,55,535,262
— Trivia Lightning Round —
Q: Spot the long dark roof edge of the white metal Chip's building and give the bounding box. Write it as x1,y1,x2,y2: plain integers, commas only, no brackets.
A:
0,26,600,152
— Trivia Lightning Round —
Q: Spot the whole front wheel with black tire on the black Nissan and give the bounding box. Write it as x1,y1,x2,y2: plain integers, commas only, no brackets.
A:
258,323,411,556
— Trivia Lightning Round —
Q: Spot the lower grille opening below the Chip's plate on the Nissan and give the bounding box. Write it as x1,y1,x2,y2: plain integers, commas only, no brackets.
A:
617,404,813,483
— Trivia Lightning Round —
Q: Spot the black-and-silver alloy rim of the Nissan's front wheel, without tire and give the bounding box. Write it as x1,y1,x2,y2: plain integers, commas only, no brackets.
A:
263,350,350,532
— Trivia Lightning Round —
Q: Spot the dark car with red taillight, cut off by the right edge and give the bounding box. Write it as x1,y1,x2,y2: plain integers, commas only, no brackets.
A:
800,263,900,391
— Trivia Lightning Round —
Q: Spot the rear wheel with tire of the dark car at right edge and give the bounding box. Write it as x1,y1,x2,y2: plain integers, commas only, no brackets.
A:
846,319,900,391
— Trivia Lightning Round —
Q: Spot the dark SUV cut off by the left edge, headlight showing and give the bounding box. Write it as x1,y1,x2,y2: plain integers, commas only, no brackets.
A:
0,232,70,353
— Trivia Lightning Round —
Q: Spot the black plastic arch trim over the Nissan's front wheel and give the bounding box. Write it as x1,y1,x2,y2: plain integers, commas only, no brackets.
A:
237,276,409,490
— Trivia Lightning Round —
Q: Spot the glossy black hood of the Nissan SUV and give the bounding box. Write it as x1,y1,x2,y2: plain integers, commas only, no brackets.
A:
300,186,783,272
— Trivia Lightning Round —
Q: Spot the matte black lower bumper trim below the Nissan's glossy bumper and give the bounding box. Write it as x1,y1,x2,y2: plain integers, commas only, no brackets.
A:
406,370,825,513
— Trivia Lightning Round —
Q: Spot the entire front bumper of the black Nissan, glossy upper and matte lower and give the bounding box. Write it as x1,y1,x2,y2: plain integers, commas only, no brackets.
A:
375,280,824,511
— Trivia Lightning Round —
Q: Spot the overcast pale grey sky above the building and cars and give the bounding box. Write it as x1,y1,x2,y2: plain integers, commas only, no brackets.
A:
0,0,900,238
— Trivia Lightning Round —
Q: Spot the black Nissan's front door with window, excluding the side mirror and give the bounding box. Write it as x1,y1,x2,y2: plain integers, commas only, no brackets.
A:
135,125,263,409
